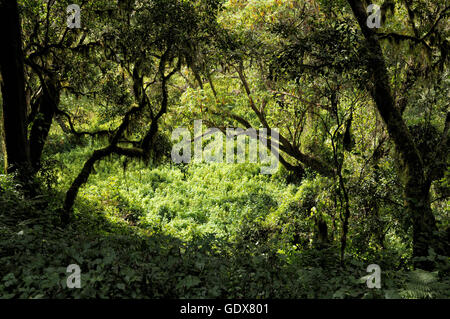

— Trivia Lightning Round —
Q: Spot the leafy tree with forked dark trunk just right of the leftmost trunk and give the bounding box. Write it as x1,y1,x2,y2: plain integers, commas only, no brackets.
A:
22,0,110,173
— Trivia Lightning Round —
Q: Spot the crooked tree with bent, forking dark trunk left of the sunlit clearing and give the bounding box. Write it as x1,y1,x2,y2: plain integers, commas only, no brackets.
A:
63,0,222,223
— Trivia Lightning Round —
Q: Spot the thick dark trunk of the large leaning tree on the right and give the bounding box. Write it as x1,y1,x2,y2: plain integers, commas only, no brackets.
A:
348,0,437,267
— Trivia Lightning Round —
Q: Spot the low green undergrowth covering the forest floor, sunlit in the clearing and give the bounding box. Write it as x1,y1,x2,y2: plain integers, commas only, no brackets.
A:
0,163,449,298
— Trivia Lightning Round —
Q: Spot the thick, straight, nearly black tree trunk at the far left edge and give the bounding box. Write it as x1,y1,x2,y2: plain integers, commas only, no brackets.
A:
0,1,30,182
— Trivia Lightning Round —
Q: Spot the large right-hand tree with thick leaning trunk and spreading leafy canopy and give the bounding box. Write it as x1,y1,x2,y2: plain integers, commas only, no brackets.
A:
194,1,450,266
